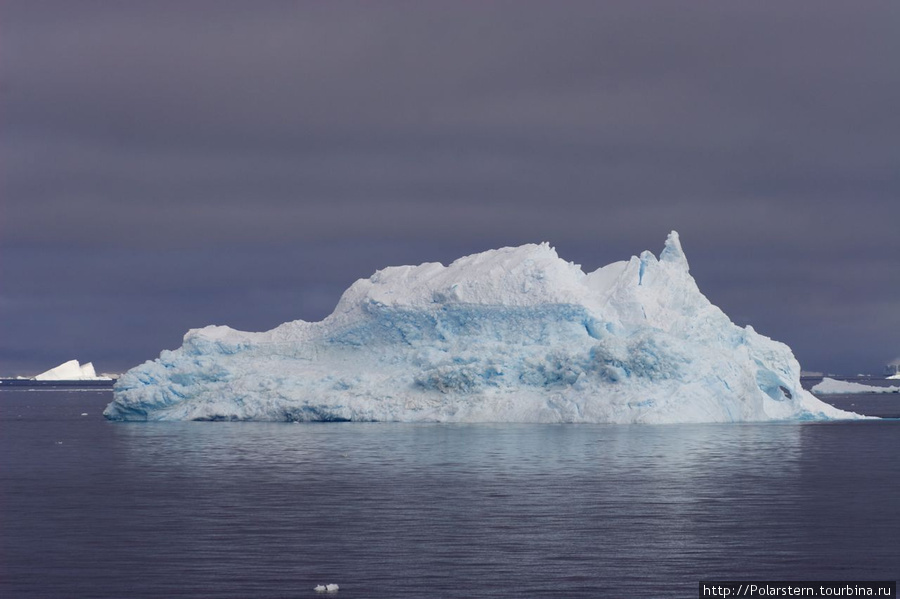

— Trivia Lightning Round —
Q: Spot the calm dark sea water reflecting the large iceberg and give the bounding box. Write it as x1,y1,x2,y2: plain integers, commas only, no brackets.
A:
0,391,900,599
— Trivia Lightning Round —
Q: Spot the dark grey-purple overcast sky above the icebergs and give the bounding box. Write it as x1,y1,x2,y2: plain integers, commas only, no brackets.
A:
0,0,900,375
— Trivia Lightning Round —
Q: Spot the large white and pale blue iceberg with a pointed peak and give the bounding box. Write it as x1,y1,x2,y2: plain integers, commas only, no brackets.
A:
105,232,857,423
